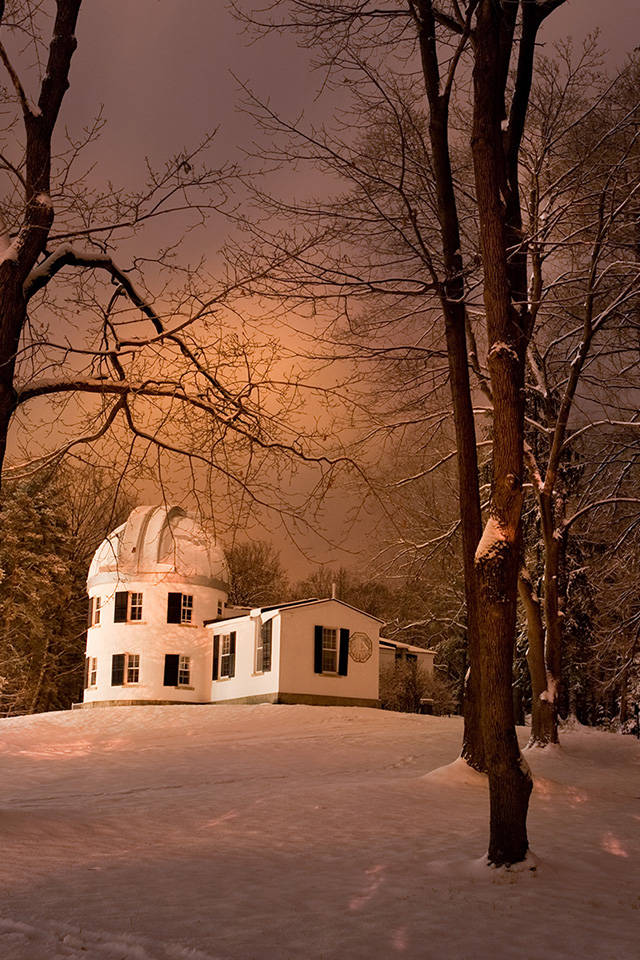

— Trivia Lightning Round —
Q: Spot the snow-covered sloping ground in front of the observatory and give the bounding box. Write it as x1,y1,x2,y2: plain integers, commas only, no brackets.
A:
0,705,640,960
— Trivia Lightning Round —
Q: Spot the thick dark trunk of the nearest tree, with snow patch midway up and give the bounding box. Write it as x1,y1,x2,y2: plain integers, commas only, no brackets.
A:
471,0,532,866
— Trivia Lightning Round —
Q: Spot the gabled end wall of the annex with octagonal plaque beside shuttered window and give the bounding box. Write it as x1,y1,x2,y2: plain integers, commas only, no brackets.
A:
279,600,380,702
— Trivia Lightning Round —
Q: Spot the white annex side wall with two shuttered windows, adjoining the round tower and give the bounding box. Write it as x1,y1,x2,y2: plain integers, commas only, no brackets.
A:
208,611,280,702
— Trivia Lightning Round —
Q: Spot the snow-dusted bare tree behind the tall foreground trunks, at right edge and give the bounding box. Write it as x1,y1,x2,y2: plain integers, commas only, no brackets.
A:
520,47,640,746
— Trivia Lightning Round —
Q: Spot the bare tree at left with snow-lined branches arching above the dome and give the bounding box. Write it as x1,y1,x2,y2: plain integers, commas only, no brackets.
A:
0,0,345,532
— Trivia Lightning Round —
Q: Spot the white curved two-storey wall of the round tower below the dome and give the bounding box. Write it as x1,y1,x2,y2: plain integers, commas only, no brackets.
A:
84,574,226,703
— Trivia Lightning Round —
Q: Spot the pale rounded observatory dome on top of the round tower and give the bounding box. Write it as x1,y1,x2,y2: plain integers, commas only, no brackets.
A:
87,506,228,589
